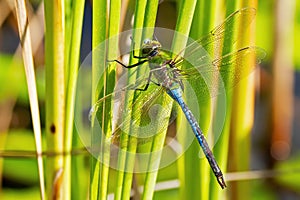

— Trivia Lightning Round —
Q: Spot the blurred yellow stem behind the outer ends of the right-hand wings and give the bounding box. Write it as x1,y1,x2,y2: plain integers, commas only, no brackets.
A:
229,0,257,199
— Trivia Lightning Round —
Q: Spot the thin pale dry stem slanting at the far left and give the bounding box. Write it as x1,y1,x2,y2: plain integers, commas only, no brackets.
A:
14,0,46,199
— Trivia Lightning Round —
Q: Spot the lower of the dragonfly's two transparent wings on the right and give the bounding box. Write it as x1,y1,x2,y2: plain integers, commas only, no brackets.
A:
177,47,266,97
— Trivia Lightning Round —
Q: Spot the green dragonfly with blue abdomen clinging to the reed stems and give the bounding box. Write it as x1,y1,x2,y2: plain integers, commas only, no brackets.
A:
91,8,264,189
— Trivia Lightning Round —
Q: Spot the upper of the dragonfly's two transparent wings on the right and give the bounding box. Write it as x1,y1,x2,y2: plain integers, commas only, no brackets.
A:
174,8,256,64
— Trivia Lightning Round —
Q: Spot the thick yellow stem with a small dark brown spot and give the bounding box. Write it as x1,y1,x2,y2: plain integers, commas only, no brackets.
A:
44,0,68,199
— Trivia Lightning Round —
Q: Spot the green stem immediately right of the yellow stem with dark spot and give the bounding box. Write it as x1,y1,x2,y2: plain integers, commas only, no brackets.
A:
65,0,85,197
